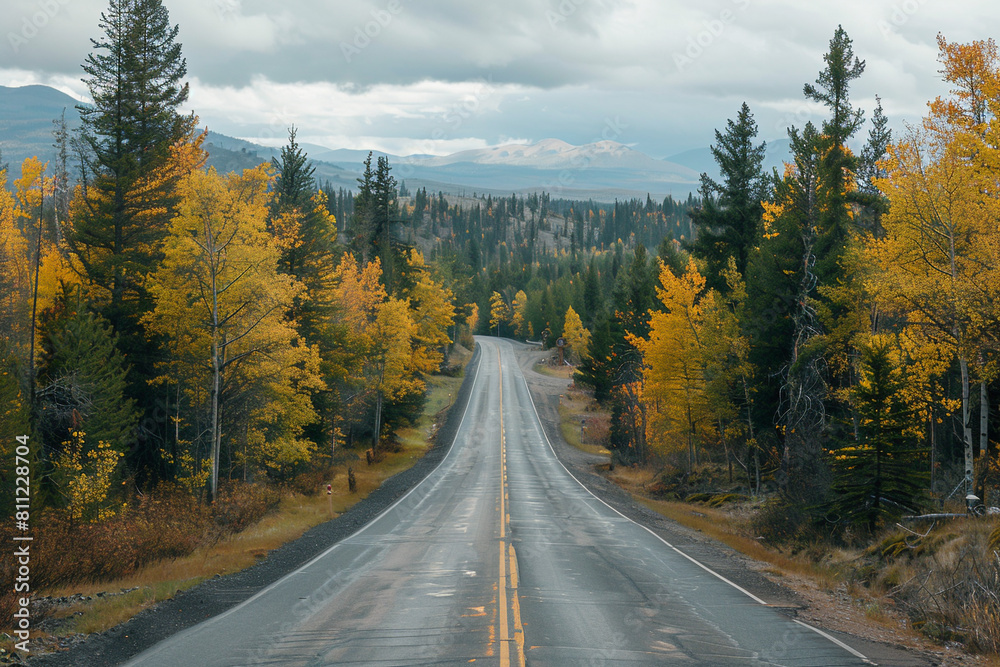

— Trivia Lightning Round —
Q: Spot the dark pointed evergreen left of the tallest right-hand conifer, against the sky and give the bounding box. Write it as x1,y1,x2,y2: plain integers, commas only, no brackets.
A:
691,102,769,292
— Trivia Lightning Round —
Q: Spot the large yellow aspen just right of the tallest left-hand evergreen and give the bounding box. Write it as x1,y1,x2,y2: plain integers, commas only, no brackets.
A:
145,167,322,499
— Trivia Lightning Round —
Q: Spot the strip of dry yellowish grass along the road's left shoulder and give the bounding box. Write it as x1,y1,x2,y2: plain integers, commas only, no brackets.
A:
31,362,471,635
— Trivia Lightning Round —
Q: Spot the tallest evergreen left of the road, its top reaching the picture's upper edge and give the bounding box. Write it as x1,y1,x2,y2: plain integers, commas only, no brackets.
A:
66,0,197,483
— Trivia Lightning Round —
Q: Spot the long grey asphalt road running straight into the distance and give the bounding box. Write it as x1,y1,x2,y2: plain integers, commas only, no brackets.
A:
121,339,865,667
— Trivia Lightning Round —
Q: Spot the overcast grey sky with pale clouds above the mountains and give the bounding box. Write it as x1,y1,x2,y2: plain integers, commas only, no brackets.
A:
0,0,1000,157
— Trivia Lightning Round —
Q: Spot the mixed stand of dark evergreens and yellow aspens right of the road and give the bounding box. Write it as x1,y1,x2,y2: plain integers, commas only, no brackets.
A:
578,29,1000,533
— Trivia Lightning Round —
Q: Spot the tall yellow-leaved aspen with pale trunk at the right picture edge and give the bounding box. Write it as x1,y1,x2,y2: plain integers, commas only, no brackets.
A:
868,35,1000,495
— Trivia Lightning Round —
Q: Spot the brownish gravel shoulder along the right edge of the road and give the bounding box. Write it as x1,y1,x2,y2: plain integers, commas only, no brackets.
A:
514,343,982,667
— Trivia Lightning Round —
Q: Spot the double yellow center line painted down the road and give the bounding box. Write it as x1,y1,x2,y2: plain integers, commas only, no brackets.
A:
497,348,524,667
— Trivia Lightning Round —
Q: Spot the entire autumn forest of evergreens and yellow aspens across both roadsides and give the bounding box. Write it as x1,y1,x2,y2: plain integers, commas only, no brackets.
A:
0,0,1000,648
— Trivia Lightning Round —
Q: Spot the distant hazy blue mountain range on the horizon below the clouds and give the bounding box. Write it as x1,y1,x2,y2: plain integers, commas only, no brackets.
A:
0,85,788,201
